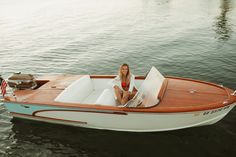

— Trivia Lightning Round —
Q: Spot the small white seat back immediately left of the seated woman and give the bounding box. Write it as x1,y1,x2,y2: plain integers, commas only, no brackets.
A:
95,89,116,106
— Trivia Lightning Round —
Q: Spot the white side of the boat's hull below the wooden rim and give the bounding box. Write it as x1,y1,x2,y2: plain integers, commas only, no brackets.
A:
10,103,236,132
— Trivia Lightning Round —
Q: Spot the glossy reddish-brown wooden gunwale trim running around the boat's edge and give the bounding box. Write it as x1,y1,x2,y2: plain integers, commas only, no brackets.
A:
5,75,236,113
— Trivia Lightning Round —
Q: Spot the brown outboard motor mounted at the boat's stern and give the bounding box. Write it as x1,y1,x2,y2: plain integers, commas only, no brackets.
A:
7,72,37,89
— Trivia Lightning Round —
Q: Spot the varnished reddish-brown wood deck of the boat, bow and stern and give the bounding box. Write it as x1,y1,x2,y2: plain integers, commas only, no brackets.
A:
6,75,236,112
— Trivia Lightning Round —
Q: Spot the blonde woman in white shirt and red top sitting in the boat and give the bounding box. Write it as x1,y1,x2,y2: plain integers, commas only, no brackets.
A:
113,64,137,105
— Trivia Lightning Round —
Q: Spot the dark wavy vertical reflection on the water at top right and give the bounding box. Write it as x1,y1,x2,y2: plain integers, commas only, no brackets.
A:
215,0,232,40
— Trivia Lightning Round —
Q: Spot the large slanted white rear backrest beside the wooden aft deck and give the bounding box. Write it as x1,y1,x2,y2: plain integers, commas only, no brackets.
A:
55,75,94,103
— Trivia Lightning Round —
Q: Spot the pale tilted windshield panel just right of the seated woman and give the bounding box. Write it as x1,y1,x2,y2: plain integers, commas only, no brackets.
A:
139,67,165,107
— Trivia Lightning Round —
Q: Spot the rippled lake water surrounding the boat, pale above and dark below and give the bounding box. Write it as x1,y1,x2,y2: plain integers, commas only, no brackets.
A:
0,0,236,157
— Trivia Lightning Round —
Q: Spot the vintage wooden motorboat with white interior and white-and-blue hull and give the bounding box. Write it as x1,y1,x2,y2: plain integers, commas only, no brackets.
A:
1,67,236,132
